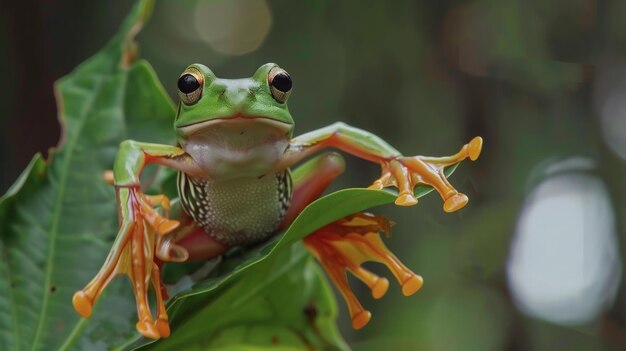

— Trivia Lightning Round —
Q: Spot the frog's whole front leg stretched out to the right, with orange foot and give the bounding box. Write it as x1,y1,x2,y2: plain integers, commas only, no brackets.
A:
281,122,482,212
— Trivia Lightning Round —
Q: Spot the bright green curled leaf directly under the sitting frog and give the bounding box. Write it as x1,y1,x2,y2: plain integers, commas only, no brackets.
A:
127,165,457,350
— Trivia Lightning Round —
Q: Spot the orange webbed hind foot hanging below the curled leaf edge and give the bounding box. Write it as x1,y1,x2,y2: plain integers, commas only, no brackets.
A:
304,213,423,329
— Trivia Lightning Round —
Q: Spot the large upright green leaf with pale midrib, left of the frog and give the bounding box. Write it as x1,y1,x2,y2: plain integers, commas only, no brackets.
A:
0,1,179,350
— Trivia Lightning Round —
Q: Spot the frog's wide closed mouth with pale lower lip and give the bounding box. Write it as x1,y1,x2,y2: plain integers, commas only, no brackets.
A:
177,115,293,137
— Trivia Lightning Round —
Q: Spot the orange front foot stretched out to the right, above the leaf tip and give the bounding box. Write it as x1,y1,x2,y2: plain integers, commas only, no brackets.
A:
369,137,483,212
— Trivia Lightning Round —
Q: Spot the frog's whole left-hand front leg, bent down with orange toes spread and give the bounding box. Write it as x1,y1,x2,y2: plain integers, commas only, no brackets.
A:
72,141,200,338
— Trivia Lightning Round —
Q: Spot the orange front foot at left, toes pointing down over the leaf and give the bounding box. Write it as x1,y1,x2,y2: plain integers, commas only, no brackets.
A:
72,187,179,339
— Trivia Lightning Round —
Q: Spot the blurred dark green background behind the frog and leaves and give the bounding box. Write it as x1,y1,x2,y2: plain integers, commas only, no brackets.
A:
0,0,626,351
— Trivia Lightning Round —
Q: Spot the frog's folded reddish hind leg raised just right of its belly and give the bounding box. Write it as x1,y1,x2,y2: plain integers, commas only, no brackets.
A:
281,152,346,228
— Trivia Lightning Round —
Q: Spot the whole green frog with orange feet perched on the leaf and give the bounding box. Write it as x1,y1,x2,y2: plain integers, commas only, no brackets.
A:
72,63,483,339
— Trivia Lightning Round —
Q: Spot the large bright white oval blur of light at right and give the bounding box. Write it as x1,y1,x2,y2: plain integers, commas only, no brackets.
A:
507,159,621,325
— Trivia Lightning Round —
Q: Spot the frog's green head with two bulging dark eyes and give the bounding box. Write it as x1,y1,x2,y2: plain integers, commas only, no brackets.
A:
174,63,293,145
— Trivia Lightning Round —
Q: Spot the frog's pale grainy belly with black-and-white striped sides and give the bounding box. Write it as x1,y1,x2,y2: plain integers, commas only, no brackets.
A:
178,171,291,245
